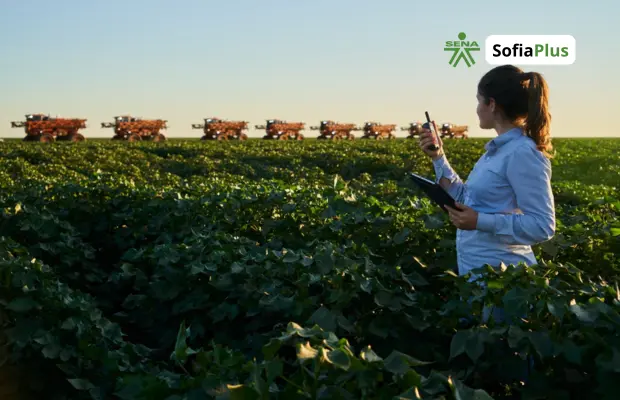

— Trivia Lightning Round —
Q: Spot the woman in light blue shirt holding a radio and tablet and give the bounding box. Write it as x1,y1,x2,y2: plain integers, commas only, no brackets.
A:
420,65,555,320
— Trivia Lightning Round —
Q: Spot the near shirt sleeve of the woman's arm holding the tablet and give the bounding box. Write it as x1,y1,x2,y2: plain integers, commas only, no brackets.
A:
476,146,555,245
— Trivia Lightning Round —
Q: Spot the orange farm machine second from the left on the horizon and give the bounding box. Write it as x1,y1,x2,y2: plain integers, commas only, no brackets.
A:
101,115,168,142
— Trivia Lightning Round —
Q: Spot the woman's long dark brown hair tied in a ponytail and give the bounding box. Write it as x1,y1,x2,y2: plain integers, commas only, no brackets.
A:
478,65,553,158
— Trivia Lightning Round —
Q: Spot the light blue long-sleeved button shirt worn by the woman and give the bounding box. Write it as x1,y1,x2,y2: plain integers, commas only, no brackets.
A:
433,128,555,275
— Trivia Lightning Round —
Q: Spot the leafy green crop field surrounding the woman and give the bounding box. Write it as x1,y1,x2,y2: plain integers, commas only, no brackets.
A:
0,139,620,400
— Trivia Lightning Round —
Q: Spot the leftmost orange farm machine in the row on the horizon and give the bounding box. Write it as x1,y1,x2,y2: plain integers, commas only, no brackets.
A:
11,114,86,142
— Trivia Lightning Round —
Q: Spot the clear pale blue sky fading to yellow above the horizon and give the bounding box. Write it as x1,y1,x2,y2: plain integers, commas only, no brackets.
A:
0,0,620,137
